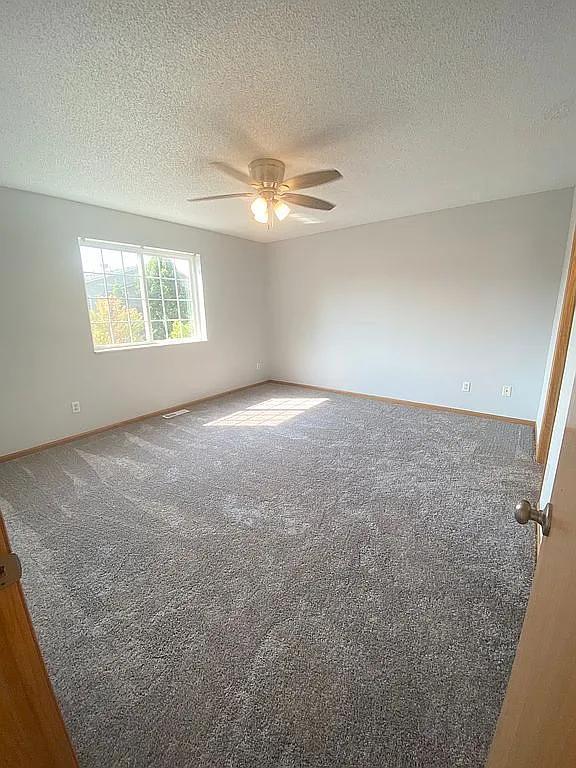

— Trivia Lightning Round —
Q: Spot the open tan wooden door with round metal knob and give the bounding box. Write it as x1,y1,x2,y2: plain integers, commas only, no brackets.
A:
487,376,576,768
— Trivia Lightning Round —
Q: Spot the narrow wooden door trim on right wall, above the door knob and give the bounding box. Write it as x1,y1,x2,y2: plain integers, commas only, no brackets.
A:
536,229,576,464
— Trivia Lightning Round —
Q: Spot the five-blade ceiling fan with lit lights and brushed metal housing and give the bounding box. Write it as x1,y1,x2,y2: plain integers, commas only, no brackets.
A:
188,157,342,228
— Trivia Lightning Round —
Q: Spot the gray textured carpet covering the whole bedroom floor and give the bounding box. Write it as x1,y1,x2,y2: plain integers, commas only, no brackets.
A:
0,384,540,768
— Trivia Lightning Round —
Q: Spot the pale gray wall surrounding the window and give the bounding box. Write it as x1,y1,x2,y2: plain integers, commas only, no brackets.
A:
0,189,266,455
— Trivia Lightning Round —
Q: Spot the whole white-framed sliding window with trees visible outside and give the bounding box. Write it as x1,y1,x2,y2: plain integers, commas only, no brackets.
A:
78,238,206,351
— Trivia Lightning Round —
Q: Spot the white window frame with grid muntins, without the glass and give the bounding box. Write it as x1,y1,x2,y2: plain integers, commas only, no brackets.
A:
78,237,208,354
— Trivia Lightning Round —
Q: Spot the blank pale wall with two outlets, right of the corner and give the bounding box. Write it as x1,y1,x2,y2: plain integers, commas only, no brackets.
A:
268,190,572,419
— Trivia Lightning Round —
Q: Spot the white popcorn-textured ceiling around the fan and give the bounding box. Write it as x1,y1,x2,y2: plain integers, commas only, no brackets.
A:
0,0,576,240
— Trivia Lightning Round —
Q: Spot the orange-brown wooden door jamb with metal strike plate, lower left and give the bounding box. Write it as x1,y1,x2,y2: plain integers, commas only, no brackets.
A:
0,517,78,768
